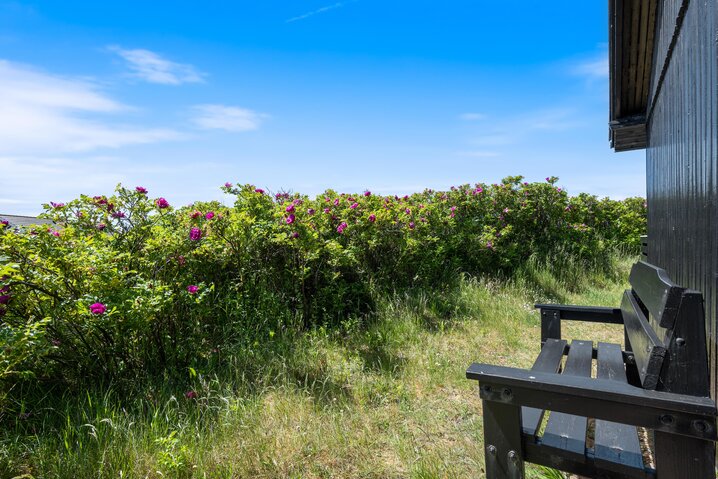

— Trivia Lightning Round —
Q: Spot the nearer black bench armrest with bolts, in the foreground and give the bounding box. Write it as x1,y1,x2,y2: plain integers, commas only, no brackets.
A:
466,363,716,441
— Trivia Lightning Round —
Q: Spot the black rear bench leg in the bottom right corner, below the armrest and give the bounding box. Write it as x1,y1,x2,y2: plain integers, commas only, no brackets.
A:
654,431,716,479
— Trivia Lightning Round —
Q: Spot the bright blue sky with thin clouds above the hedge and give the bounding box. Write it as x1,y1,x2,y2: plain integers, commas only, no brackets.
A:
0,0,645,214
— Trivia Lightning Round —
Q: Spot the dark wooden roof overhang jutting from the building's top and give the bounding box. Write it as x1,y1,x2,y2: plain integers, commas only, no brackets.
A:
608,0,658,151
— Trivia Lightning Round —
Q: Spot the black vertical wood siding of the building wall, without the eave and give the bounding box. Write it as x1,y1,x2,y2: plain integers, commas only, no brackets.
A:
646,0,718,398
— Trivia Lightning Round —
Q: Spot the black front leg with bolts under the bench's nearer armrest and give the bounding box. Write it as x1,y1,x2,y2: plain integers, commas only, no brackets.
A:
483,401,524,479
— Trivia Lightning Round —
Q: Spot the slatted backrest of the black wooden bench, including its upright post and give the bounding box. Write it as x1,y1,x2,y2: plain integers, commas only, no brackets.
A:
621,261,709,396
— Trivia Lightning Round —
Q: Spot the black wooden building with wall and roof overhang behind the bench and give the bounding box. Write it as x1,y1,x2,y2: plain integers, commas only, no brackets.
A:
609,0,718,398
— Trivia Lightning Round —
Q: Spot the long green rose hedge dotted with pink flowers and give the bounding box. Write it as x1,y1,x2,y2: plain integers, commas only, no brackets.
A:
0,177,646,385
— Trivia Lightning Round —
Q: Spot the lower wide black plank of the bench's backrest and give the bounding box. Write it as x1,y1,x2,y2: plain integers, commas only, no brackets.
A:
621,291,666,389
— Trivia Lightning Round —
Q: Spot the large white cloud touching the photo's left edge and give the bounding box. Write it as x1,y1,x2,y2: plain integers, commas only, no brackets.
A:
0,60,180,155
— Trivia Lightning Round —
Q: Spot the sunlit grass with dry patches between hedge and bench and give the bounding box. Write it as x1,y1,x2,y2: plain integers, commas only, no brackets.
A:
0,258,632,479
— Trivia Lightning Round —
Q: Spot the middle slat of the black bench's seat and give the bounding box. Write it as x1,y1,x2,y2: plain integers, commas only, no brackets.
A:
541,340,593,457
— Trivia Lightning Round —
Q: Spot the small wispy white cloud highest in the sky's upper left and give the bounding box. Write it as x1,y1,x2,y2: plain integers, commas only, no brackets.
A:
108,46,206,85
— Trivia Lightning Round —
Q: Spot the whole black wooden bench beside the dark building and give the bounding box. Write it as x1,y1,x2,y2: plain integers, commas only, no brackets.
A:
466,261,716,479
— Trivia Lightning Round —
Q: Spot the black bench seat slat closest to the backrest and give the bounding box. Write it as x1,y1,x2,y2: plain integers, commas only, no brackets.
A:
594,343,643,472
